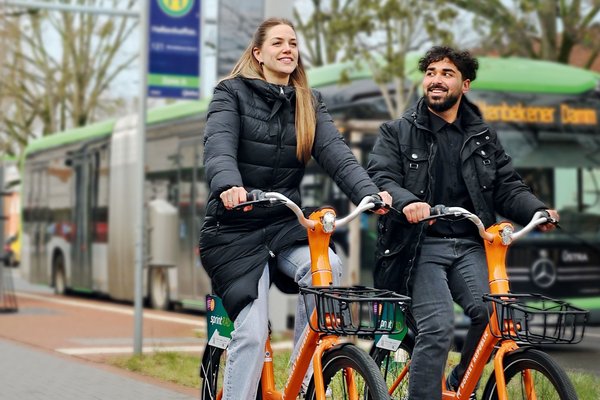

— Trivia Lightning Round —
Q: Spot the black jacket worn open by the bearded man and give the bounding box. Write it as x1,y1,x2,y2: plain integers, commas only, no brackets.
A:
368,97,547,294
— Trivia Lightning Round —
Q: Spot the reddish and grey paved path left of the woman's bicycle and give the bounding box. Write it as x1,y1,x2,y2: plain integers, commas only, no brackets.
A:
0,268,205,400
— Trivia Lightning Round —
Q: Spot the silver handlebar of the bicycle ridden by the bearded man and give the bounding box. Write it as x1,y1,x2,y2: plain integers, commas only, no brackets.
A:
421,205,557,245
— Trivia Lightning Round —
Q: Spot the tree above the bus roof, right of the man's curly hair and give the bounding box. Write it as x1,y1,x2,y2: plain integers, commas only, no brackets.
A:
449,0,600,68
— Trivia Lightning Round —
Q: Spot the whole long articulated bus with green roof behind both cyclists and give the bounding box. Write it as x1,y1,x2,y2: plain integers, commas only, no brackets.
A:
21,56,600,329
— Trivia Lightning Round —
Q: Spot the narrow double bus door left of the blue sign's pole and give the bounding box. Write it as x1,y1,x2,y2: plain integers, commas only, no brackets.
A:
71,147,99,290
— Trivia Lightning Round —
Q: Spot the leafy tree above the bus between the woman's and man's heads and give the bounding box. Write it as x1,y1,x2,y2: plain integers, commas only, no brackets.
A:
296,0,456,118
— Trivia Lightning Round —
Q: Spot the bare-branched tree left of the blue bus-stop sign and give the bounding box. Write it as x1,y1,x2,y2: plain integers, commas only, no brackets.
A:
0,0,138,152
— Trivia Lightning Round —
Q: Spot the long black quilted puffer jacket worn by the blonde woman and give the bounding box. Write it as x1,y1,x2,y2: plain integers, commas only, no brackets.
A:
200,78,379,318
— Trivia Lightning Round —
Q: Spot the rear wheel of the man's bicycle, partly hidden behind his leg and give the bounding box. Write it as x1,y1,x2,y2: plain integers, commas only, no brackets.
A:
369,335,415,399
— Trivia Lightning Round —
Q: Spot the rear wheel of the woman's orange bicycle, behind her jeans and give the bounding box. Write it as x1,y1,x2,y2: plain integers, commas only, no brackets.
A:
200,345,262,400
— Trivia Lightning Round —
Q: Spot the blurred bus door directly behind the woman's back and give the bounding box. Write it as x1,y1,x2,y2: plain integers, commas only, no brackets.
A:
177,139,210,308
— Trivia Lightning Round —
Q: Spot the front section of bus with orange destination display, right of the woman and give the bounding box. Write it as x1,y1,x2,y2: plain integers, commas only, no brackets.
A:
319,55,600,322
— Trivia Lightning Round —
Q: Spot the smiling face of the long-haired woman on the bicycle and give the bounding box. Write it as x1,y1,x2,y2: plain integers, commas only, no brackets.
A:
253,24,298,85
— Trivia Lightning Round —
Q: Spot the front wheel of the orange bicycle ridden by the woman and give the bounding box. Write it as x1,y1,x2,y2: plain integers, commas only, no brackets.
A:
305,344,390,400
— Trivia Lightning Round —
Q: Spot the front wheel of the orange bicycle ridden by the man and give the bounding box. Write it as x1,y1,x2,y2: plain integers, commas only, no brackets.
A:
482,348,577,400
